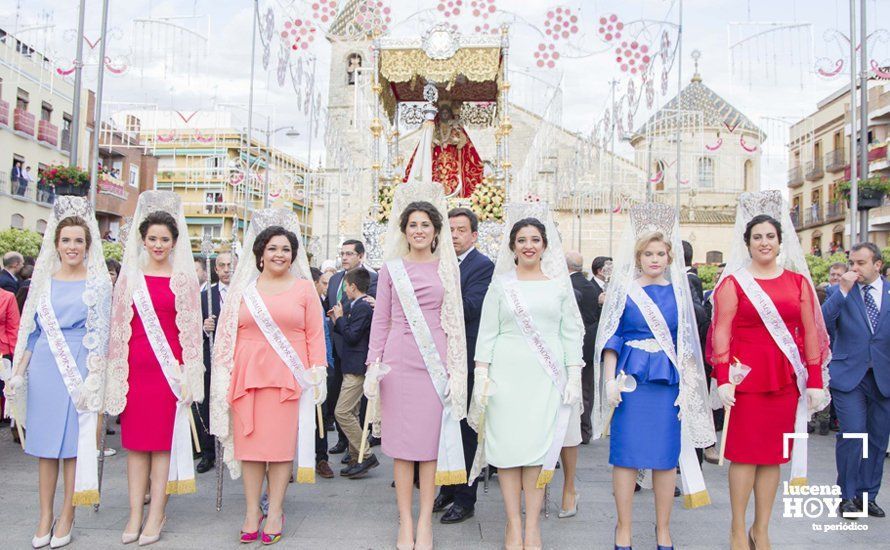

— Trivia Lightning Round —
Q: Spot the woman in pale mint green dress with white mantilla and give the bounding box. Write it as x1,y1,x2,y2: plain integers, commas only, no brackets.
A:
470,213,584,549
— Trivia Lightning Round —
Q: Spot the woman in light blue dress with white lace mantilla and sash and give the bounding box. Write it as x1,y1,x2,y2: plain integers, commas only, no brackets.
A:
7,196,111,548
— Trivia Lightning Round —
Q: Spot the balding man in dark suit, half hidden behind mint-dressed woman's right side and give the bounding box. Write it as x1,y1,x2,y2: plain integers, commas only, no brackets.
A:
566,251,601,445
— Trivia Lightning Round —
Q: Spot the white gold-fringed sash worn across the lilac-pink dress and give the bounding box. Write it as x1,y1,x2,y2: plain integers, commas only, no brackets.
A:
386,259,467,485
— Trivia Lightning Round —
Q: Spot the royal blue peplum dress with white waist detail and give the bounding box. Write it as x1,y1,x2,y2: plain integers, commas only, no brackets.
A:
603,284,680,470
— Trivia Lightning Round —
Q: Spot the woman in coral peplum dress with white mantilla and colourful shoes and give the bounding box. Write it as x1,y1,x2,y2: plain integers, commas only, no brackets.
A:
210,209,327,544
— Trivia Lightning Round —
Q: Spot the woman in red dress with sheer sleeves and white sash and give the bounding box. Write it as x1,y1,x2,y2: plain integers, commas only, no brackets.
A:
708,208,828,550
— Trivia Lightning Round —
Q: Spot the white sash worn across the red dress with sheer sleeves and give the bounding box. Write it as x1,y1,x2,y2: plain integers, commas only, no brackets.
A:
733,269,809,485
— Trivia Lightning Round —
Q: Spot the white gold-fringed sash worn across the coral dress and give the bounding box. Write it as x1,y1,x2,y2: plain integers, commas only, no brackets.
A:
244,281,315,483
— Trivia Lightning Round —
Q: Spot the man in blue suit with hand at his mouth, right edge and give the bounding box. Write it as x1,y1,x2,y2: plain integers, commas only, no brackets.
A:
822,243,890,519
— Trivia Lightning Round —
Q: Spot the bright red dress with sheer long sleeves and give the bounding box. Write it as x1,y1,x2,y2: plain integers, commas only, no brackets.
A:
709,269,822,464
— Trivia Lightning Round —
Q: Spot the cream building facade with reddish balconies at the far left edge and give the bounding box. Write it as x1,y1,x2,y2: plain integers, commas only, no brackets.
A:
0,29,91,233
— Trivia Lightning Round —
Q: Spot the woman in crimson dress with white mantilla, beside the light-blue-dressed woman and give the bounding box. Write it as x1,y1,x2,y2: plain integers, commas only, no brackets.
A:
106,191,203,546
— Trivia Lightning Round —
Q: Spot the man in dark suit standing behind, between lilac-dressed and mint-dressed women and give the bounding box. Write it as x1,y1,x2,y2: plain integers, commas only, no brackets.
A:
433,208,494,524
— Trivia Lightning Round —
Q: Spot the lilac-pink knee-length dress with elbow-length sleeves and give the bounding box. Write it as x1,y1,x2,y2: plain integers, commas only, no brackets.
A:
367,260,446,462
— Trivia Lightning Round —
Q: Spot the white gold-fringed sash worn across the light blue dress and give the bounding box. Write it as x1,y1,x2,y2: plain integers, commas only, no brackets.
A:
37,284,99,506
